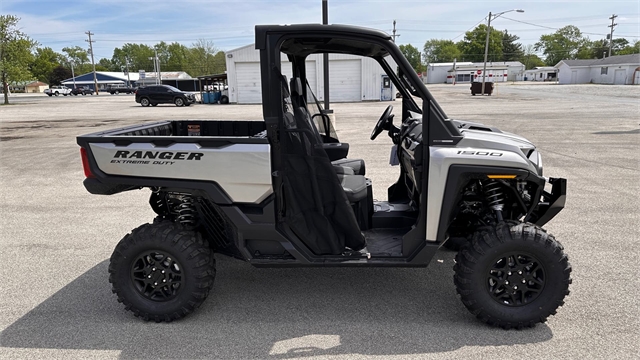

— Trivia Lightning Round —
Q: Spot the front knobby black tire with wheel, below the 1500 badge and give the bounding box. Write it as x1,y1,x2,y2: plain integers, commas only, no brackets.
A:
454,221,571,329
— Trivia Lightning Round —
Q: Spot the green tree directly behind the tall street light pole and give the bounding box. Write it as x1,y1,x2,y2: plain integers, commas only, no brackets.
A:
460,24,503,62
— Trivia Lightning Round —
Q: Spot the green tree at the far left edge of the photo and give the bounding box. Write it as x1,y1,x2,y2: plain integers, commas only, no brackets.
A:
0,15,37,104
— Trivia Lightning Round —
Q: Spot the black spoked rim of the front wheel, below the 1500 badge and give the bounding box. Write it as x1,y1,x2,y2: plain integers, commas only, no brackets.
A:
487,252,545,306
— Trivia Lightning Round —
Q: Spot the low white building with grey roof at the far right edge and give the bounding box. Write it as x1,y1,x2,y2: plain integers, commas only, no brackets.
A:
555,54,640,85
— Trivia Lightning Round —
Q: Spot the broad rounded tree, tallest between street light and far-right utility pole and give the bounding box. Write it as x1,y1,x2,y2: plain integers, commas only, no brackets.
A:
535,25,591,66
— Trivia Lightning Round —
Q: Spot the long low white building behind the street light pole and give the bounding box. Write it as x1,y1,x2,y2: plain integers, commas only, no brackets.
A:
426,61,525,84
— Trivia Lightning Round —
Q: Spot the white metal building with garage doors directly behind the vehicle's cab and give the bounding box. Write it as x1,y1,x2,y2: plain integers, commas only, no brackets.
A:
225,44,397,104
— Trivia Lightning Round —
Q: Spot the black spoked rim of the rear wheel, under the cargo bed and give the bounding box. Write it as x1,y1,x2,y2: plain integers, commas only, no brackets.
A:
131,251,182,301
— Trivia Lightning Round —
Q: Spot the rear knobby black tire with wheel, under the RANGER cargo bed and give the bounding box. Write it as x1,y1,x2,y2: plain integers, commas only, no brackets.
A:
109,219,216,322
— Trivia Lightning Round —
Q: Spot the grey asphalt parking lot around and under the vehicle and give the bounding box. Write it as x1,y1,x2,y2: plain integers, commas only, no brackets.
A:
0,84,640,359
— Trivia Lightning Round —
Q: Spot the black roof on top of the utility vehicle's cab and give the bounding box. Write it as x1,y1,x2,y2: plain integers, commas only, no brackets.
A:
256,24,391,56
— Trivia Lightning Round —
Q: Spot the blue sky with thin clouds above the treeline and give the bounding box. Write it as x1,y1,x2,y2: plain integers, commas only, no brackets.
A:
0,0,640,61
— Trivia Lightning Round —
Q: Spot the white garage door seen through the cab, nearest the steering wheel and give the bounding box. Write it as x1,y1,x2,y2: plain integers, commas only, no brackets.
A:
329,59,362,102
